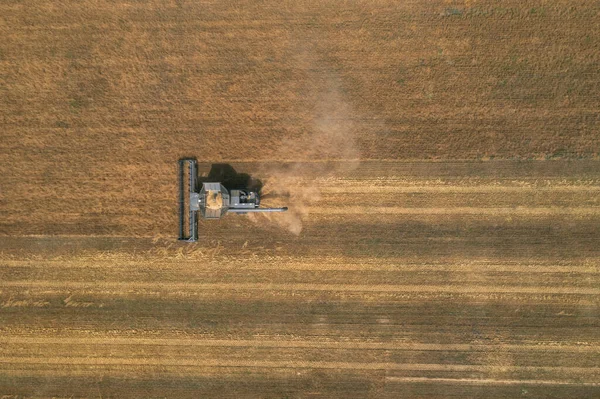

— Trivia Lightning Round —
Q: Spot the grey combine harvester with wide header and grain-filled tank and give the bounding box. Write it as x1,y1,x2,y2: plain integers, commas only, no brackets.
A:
179,158,287,242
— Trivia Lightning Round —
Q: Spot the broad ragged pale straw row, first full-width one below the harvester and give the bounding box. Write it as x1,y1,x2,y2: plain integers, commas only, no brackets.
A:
0,260,600,275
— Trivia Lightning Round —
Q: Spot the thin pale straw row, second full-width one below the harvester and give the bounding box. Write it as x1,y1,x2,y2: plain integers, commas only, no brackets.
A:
0,280,600,295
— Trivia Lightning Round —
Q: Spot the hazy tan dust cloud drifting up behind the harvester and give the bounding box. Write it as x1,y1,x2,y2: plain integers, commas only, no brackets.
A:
251,76,360,235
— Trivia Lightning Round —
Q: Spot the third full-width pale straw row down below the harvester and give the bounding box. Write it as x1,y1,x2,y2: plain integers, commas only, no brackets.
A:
0,336,600,353
